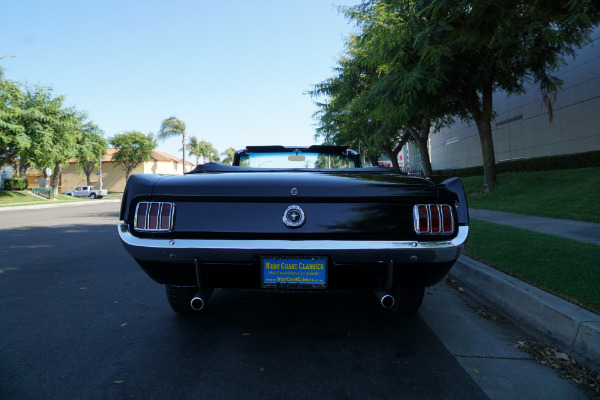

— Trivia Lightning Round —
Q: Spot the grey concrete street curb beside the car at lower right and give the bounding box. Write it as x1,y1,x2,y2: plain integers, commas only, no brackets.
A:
449,256,600,372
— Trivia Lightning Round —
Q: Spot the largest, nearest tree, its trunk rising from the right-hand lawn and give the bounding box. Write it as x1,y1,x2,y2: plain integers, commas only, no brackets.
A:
350,0,600,191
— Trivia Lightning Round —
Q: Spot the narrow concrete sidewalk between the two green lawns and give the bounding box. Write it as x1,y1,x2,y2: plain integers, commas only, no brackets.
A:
469,208,600,245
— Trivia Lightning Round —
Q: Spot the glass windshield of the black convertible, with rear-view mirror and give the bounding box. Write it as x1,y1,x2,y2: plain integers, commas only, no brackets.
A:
240,152,356,169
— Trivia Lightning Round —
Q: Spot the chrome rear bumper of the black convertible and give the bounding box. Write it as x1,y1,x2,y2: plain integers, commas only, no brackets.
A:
118,224,469,262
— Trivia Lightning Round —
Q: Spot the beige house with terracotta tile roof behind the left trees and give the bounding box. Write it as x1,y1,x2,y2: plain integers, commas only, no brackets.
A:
59,149,194,193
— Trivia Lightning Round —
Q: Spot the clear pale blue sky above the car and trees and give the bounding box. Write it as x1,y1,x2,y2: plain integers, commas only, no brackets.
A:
0,0,360,161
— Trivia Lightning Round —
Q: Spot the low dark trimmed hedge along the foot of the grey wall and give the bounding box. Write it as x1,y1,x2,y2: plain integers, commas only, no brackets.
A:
434,151,600,176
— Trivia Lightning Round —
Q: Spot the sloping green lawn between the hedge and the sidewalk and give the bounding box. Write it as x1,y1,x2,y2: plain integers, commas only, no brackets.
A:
462,167,600,223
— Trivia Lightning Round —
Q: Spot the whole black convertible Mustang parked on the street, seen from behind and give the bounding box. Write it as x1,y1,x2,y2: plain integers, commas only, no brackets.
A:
118,146,469,314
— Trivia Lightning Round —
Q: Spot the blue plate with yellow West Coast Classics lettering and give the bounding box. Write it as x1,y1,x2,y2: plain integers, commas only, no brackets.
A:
261,256,327,289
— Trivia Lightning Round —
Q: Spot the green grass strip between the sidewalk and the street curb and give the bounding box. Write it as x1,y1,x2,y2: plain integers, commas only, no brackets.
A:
465,219,600,313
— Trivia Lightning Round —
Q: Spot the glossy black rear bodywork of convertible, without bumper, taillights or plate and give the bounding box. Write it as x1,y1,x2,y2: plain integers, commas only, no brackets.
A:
120,162,468,290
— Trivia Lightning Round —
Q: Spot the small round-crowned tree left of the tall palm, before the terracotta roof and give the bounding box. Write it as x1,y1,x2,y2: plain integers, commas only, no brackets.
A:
109,131,157,180
